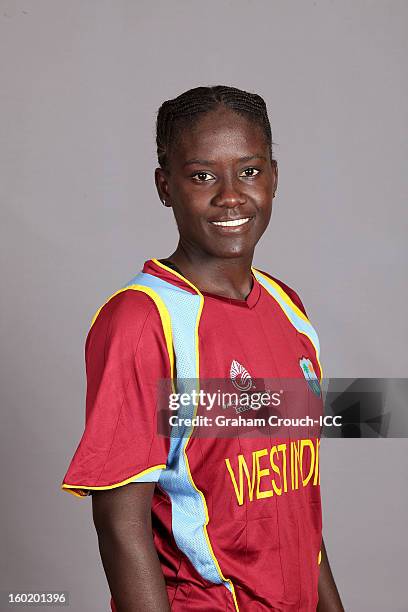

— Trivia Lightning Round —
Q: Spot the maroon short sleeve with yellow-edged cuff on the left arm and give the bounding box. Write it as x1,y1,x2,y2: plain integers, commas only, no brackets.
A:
61,289,171,497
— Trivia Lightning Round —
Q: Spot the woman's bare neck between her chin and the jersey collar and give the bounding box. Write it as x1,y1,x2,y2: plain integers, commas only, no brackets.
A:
163,244,253,300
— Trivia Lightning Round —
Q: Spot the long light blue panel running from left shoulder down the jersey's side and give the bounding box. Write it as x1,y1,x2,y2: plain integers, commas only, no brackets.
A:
122,272,231,590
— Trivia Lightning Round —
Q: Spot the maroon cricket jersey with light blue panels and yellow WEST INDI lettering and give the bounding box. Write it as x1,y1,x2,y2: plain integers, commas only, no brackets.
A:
61,259,323,612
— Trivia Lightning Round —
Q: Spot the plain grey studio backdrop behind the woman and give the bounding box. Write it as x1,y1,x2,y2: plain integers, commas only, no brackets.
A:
0,0,408,612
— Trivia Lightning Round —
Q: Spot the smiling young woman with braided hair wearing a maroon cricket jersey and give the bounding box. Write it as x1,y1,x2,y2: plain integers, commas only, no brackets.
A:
62,86,343,612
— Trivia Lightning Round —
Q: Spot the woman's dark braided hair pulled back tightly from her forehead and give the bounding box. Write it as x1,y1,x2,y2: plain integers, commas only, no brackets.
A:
156,85,273,169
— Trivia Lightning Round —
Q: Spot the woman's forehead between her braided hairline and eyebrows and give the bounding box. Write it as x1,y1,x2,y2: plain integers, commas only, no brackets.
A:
172,108,268,161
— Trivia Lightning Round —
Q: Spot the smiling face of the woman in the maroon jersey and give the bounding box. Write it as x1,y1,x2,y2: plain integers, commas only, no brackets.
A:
155,108,277,259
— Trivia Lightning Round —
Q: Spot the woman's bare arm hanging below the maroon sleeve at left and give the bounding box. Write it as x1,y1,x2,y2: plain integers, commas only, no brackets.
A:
92,482,170,612
